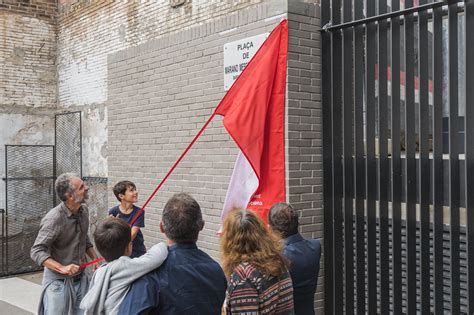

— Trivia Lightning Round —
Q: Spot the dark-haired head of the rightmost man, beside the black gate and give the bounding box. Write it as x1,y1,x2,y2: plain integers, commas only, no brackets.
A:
268,202,299,238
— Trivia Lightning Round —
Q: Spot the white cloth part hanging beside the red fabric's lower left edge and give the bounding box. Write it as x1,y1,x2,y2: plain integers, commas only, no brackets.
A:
221,151,258,221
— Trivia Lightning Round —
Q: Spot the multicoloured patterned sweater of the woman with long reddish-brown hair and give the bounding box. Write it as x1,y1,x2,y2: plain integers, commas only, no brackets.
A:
226,262,294,315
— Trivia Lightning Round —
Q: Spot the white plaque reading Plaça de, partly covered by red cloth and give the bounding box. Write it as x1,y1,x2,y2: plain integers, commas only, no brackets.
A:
224,33,270,91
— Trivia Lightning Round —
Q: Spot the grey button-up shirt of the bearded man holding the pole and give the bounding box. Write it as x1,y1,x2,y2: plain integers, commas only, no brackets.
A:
31,202,92,266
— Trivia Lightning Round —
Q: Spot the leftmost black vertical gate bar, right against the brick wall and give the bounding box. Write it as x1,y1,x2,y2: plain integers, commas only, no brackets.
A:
321,1,334,314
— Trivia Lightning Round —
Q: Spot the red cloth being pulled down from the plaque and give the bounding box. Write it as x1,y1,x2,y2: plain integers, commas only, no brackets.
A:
215,20,288,222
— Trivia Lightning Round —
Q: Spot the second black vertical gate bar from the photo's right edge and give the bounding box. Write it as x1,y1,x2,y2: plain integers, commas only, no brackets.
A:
448,2,460,314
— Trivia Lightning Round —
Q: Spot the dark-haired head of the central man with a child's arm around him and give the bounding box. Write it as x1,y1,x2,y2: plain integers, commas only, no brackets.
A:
161,193,204,243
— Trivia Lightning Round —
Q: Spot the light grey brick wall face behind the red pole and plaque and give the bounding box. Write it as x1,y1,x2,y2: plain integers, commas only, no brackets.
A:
107,0,283,258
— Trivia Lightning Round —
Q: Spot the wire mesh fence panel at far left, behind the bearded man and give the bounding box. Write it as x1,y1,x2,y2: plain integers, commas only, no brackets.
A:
0,145,55,274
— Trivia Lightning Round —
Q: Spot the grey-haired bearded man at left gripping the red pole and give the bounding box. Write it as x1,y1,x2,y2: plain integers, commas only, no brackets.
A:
31,173,98,314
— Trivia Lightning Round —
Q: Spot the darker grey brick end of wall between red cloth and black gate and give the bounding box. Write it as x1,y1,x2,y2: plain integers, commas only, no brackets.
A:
287,1,324,314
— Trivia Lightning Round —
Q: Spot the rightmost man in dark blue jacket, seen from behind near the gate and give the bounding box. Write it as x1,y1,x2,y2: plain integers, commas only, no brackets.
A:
268,202,321,315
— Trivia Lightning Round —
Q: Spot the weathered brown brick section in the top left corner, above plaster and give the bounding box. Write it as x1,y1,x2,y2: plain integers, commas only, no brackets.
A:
0,1,56,107
